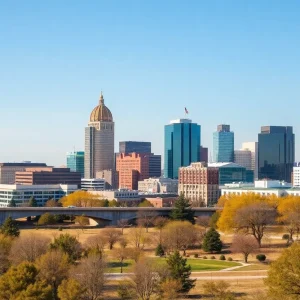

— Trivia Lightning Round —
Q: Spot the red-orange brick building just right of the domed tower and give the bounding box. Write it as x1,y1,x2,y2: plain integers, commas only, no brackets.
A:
116,152,150,190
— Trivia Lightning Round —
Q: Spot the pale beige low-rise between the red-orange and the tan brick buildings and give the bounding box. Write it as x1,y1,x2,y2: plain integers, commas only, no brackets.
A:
138,177,178,193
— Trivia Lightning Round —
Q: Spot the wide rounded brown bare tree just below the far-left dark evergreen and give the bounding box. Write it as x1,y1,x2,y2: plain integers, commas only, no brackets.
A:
10,233,50,265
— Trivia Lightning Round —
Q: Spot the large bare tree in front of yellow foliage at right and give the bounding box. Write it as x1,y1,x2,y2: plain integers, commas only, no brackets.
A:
234,202,276,247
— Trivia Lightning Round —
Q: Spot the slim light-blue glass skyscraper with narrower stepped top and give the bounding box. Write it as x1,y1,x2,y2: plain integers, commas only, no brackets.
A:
213,124,234,162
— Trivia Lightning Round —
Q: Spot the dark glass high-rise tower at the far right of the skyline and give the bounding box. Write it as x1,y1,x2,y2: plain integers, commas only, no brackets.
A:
258,126,295,182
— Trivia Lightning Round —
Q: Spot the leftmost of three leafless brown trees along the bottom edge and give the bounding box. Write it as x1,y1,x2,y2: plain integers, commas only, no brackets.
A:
37,251,70,299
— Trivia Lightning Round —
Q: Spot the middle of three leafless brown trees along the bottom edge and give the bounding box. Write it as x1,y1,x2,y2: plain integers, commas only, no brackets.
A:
72,254,106,300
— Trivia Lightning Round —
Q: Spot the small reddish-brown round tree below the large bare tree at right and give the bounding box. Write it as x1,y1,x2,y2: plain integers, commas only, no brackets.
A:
232,234,259,263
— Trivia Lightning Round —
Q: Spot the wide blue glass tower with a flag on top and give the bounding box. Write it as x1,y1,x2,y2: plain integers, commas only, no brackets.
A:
164,119,201,179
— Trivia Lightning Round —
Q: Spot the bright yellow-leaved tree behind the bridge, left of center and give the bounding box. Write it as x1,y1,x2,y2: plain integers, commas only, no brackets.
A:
60,191,108,207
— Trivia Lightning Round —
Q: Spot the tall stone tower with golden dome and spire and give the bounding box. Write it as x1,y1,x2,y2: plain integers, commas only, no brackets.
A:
84,93,114,178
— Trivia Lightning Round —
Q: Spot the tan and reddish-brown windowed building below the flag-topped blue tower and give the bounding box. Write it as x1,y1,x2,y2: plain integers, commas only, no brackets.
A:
178,162,219,207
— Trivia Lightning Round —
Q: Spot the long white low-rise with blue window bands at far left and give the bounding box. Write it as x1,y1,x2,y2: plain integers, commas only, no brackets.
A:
0,184,78,207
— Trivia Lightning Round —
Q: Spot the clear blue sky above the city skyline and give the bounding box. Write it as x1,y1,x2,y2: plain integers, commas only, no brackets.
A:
0,0,300,165
